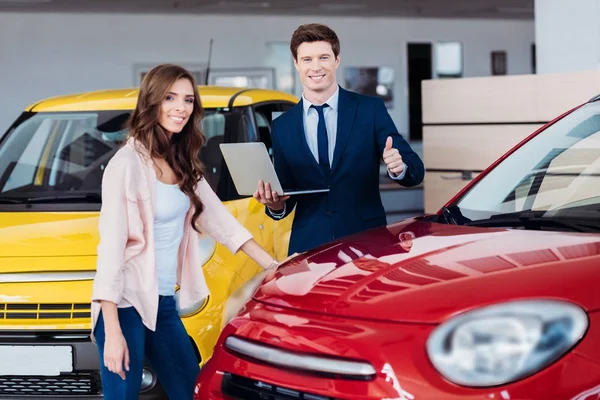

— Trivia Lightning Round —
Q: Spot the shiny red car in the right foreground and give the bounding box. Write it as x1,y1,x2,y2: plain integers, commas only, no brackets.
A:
196,97,600,400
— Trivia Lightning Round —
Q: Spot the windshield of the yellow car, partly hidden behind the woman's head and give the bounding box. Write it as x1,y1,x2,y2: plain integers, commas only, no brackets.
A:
0,109,247,210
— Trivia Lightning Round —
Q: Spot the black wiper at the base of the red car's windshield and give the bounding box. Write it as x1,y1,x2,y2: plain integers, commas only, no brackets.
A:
465,211,600,232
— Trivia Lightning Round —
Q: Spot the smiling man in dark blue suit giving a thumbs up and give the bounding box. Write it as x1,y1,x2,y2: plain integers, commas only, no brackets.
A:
254,24,424,254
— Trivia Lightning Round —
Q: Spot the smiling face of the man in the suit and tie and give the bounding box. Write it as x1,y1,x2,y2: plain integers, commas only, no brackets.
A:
294,42,340,92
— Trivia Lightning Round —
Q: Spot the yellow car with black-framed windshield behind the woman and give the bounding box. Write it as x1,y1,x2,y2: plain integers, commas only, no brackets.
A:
0,86,297,399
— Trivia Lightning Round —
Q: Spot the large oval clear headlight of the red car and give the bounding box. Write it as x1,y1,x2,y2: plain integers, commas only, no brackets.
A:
427,300,588,387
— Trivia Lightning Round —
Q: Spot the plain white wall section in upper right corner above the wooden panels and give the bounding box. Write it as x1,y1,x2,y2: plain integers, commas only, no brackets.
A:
535,0,600,73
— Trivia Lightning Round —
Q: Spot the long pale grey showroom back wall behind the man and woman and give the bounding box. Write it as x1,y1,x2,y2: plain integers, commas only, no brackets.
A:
0,13,534,139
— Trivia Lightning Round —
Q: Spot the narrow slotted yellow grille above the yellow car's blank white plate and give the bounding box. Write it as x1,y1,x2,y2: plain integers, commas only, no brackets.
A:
0,303,91,320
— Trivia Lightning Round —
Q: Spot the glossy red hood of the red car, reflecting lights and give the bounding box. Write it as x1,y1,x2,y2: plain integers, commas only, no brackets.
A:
254,220,600,323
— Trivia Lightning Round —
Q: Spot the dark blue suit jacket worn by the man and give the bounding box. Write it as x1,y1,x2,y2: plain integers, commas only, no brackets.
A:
267,88,425,254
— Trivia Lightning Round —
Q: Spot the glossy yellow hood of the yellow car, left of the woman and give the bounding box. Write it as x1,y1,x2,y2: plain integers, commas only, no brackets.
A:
0,212,99,272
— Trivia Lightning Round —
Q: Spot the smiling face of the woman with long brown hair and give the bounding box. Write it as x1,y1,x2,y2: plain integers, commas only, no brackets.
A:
159,78,194,136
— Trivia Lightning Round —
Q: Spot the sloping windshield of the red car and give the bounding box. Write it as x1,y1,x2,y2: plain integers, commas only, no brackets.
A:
452,101,600,226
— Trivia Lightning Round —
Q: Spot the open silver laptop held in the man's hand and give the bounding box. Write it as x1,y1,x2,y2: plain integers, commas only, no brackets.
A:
219,142,329,196
